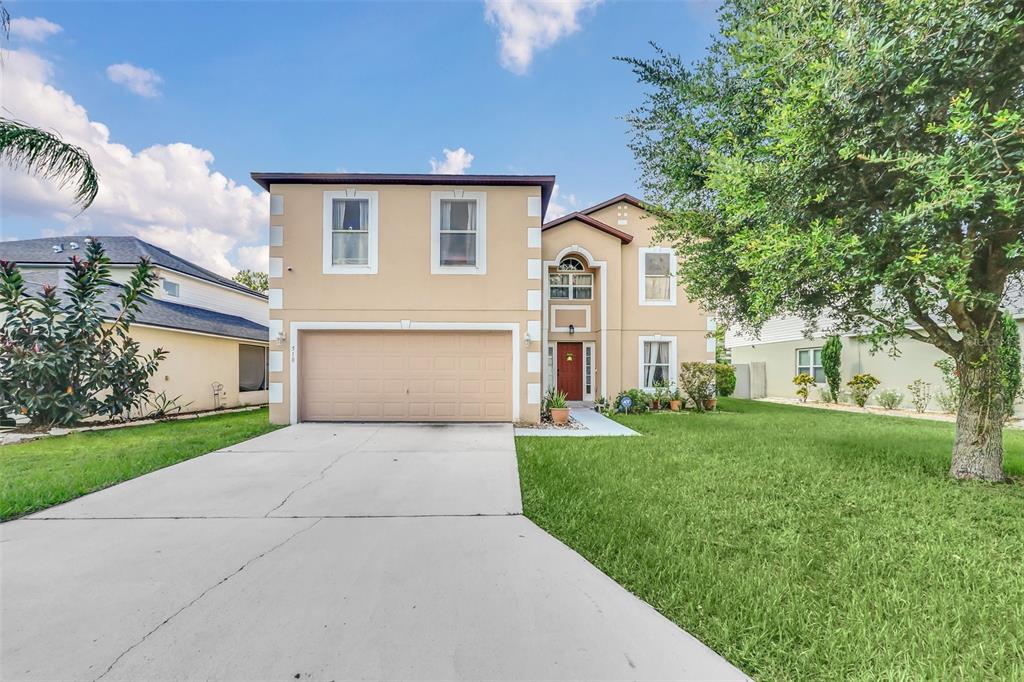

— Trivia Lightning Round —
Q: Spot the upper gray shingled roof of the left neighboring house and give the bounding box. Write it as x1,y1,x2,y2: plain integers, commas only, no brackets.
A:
0,236,266,299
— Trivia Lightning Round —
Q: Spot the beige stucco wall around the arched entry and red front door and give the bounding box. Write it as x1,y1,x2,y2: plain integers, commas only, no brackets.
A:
543,203,715,396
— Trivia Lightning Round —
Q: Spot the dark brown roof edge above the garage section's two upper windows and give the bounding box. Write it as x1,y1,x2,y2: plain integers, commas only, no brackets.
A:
250,172,555,216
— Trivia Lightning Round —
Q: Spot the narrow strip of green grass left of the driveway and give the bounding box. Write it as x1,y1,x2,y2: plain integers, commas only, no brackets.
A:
0,409,279,519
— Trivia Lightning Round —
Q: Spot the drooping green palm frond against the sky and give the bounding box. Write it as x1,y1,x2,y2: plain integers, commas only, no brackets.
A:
0,118,99,206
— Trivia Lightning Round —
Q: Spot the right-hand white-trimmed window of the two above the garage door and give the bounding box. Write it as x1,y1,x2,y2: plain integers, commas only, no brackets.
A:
430,191,486,274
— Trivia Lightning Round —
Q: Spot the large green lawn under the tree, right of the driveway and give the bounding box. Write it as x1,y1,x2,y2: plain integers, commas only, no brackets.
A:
517,399,1024,680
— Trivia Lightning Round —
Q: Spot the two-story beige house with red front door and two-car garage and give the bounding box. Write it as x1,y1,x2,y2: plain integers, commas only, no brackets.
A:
252,173,714,424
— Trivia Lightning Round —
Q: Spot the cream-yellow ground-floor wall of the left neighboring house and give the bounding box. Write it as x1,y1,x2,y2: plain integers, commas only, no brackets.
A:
131,325,267,412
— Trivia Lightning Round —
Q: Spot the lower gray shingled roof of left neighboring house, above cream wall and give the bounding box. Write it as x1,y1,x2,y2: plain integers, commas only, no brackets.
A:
18,269,270,341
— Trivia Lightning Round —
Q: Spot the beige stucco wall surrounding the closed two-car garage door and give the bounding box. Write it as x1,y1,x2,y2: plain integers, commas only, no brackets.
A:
270,184,542,424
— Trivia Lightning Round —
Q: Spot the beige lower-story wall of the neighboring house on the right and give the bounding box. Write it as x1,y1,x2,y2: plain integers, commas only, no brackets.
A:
731,323,1020,412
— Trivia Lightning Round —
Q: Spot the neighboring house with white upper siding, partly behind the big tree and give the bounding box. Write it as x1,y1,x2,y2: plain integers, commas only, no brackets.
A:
725,314,1024,412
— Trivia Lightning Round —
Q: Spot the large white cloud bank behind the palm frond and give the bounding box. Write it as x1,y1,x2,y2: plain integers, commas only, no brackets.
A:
0,50,269,274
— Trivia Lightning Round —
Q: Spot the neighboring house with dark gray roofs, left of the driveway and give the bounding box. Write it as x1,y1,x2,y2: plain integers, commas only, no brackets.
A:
0,237,268,412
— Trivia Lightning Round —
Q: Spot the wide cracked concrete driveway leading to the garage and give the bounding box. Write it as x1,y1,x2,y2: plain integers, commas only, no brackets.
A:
0,424,743,680
